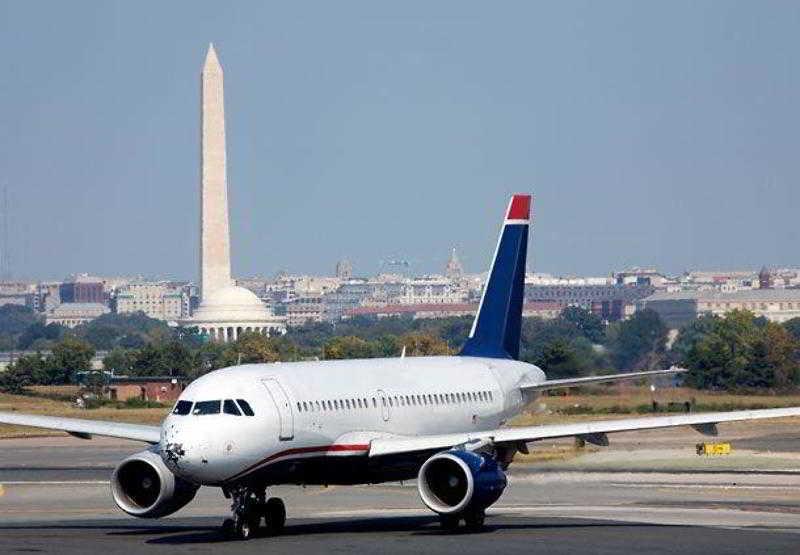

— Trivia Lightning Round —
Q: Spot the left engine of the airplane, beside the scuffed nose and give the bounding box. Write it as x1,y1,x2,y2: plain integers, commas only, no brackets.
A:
111,449,199,518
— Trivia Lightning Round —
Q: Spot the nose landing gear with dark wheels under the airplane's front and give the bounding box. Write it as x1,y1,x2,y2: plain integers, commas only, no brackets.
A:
222,487,286,540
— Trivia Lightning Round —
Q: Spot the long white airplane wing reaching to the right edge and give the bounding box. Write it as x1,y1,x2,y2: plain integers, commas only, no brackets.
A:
369,407,800,457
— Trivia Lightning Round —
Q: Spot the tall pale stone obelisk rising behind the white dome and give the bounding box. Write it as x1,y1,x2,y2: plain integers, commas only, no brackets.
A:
200,44,233,298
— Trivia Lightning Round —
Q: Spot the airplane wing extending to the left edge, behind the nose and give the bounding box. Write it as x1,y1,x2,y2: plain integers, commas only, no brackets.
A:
0,412,161,444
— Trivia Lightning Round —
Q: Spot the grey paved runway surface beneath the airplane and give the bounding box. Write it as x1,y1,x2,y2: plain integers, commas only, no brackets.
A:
0,438,800,554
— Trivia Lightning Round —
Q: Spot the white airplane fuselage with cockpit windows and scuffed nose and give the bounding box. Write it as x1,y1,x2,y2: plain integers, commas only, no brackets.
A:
160,357,545,486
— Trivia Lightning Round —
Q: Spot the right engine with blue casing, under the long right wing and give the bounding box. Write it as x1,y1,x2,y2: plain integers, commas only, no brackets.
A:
417,450,507,514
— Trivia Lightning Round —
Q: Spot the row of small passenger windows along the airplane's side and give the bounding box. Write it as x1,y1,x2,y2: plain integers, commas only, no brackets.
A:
297,391,494,412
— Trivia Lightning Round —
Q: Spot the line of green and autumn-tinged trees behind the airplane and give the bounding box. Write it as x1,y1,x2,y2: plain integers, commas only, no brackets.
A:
0,306,800,392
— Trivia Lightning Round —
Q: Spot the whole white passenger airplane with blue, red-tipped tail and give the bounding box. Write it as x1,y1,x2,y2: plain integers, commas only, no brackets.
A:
0,195,800,539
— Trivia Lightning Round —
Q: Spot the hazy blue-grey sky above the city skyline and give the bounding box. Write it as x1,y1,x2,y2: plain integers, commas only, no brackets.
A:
0,0,800,278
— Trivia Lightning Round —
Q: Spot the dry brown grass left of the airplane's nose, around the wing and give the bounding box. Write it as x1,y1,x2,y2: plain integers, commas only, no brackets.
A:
0,394,169,438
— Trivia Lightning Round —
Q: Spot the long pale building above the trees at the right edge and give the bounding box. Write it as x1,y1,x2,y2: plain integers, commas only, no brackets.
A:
638,289,800,329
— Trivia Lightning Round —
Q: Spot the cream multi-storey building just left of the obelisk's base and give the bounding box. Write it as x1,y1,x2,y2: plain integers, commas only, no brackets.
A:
114,282,188,322
